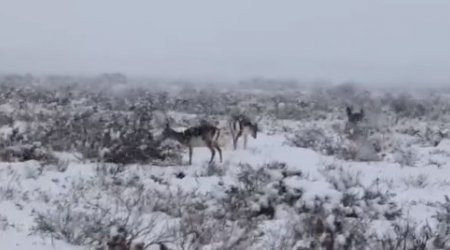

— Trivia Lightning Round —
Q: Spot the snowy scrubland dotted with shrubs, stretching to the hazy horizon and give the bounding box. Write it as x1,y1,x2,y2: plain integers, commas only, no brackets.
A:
0,75,450,250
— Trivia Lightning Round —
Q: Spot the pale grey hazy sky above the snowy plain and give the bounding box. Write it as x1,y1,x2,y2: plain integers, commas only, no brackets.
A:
0,0,450,85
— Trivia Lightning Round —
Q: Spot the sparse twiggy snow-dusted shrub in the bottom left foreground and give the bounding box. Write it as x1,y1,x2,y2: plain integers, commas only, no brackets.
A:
32,173,175,246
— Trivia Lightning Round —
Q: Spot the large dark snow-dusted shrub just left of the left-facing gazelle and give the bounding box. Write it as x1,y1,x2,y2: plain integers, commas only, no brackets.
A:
56,106,162,163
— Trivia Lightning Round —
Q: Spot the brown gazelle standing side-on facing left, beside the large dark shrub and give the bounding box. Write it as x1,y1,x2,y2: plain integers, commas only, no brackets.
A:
162,123,222,165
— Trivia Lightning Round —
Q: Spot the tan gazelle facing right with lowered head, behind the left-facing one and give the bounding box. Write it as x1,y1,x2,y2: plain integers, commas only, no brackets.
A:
229,114,258,150
